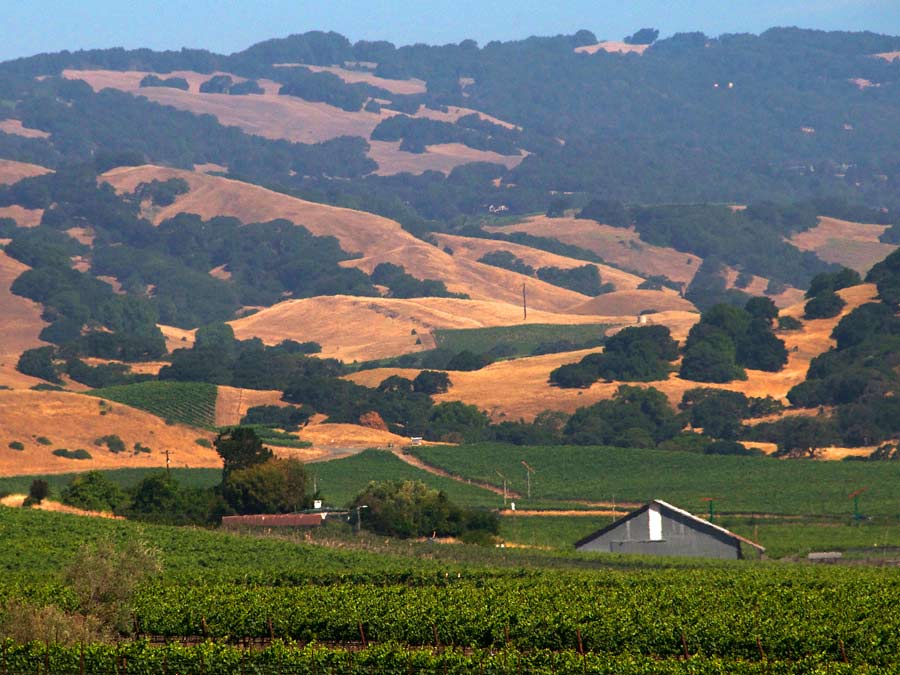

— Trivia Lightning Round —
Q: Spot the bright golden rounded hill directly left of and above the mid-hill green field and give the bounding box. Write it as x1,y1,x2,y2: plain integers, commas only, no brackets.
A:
230,295,615,361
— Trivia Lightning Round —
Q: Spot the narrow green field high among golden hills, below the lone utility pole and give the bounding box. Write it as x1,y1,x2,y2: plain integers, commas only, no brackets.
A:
434,323,609,356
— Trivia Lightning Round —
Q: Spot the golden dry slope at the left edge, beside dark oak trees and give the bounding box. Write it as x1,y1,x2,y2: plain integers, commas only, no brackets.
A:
0,251,47,390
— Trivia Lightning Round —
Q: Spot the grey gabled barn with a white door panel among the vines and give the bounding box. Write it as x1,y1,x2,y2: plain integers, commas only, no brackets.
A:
575,499,766,560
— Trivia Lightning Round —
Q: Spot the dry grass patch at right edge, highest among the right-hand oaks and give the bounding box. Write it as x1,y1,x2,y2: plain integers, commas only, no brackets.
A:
791,218,897,275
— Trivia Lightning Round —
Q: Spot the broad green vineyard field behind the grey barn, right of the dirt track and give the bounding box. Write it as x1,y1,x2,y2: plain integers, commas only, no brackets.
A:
412,443,900,516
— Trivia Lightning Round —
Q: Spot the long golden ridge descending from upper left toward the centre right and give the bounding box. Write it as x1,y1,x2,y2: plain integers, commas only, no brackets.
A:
103,166,587,311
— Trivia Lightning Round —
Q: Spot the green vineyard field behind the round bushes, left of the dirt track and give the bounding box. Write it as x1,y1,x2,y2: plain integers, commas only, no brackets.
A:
306,450,503,508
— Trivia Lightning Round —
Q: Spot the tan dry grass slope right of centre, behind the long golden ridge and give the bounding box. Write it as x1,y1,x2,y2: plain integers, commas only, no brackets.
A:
488,216,703,283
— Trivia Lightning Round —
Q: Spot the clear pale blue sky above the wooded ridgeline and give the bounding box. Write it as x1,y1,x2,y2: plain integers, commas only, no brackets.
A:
0,0,900,60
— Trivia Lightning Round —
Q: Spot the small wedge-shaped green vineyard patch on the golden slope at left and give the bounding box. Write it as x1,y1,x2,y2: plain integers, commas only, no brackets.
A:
88,382,217,429
